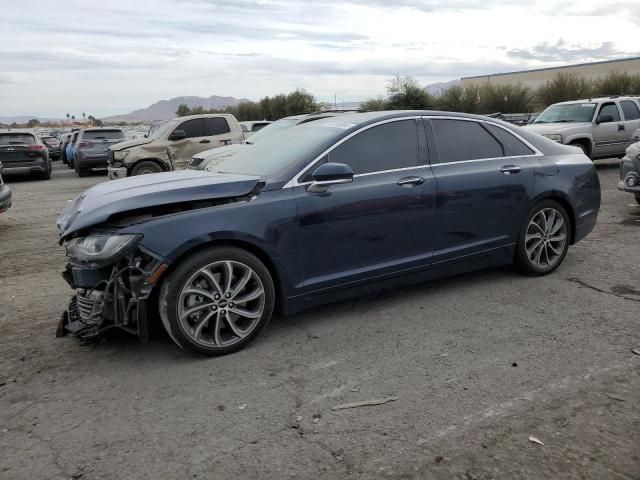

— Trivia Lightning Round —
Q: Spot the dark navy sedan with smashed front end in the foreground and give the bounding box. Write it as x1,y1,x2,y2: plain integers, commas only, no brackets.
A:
58,111,600,355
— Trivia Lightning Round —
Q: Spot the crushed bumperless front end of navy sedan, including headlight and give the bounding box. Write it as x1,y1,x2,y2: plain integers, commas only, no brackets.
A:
56,231,166,341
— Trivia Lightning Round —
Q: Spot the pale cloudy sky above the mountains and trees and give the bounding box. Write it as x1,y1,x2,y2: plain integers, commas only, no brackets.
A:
0,0,640,117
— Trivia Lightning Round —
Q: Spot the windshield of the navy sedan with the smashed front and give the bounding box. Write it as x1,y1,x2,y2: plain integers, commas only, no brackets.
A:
205,123,344,177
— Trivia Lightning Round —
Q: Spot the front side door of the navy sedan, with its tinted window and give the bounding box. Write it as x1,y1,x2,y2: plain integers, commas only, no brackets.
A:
296,119,435,292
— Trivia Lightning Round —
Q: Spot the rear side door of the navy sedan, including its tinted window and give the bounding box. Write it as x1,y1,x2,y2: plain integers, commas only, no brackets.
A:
425,117,536,267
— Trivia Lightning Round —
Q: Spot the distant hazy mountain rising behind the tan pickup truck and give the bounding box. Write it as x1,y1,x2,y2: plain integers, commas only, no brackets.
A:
101,95,249,122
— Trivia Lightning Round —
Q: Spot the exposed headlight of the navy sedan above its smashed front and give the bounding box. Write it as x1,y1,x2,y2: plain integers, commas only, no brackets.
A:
67,234,142,266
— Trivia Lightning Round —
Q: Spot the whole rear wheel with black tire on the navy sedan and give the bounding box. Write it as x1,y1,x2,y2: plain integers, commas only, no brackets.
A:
516,200,571,276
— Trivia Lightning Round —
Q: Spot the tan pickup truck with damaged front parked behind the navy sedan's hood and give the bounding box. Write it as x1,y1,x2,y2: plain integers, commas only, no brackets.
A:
108,114,244,180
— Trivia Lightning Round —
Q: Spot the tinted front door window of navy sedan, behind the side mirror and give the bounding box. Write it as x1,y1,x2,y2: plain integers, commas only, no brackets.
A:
329,120,418,175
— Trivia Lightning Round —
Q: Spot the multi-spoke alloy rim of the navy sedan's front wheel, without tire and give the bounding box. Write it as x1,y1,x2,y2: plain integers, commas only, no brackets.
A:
177,261,266,347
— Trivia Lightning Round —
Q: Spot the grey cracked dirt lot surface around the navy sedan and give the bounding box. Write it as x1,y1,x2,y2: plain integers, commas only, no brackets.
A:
0,162,640,480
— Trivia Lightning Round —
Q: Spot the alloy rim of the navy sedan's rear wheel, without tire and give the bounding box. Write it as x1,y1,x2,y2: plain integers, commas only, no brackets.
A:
525,208,567,270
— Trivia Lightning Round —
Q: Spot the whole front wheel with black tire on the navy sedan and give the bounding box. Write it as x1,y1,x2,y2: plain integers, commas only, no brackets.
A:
159,247,275,356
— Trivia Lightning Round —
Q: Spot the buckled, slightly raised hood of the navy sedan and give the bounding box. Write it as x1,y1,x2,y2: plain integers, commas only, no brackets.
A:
57,170,260,241
